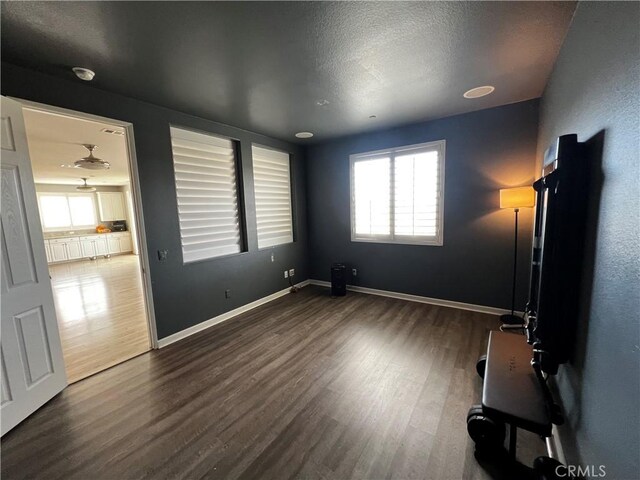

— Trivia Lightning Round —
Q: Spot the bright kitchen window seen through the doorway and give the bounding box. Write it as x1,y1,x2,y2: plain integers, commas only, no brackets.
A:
38,193,97,231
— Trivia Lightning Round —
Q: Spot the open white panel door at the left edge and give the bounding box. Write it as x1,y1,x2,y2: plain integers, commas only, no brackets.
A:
0,97,67,435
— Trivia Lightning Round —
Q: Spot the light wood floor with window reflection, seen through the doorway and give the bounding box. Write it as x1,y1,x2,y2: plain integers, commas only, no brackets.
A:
49,255,150,383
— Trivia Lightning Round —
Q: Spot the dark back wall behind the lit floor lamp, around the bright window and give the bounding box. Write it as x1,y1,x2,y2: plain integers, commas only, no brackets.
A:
307,100,538,309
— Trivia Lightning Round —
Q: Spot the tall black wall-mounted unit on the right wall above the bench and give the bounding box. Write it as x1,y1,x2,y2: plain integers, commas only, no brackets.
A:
526,134,589,375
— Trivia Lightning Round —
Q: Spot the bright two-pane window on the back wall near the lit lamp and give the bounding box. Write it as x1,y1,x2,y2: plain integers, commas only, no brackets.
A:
350,140,445,245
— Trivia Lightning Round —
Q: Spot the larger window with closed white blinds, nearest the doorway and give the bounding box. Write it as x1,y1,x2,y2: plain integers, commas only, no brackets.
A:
171,127,243,263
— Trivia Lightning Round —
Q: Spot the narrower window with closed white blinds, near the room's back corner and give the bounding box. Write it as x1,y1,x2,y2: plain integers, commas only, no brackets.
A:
252,145,293,248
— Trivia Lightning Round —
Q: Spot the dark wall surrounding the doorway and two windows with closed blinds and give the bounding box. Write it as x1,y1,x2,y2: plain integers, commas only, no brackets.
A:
2,63,308,338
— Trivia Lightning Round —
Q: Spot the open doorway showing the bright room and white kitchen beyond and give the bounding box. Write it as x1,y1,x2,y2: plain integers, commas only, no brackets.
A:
23,104,156,383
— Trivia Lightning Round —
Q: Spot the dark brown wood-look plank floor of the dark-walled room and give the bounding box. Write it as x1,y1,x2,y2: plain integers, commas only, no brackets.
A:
2,287,543,480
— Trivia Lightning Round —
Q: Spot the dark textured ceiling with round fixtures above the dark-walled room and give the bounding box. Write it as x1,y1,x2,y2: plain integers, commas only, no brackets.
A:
2,2,575,140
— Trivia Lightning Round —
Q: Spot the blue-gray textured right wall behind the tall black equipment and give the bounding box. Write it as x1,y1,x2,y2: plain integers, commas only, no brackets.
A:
538,2,640,479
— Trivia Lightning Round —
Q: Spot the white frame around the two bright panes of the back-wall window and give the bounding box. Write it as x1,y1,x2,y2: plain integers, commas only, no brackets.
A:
349,140,446,247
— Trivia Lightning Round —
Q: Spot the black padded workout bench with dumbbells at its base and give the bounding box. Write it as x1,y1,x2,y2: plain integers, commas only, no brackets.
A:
467,331,561,478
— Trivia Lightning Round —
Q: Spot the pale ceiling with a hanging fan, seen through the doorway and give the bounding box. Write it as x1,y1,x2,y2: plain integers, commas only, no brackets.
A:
24,109,129,185
